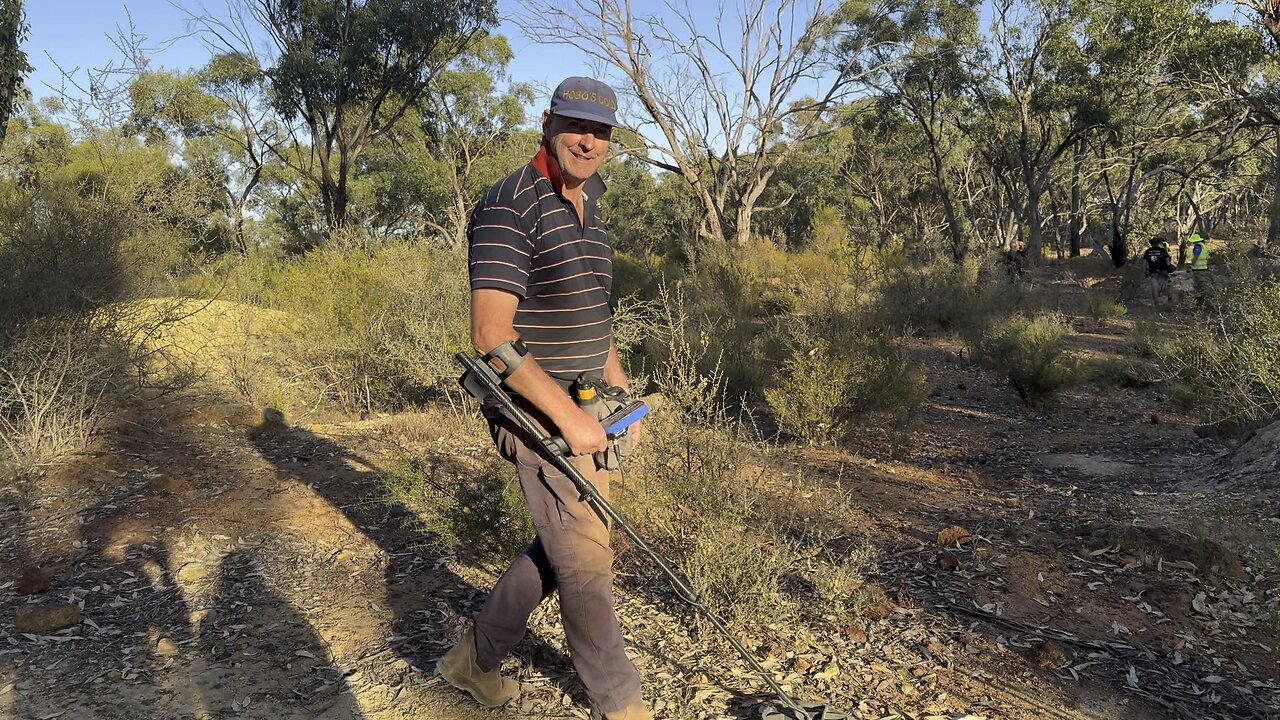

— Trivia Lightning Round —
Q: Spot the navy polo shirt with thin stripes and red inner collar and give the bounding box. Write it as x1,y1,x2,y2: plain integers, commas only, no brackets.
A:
467,145,613,380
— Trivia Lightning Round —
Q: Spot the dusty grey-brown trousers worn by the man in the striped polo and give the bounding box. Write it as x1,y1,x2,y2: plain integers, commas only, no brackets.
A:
475,407,640,712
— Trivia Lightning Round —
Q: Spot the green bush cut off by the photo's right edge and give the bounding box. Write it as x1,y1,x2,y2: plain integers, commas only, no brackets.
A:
1156,282,1280,427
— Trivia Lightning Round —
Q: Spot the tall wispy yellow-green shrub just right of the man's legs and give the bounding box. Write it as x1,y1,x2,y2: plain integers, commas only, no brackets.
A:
617,288,792,626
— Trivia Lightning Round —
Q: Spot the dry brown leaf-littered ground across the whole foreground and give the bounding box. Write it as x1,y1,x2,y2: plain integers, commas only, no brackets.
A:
0,283,1280,720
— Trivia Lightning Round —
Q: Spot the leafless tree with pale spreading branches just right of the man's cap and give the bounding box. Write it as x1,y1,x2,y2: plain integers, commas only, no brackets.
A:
517,0,900,246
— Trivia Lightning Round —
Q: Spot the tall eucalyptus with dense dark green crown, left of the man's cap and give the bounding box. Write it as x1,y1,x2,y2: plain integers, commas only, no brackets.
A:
198,0,497,231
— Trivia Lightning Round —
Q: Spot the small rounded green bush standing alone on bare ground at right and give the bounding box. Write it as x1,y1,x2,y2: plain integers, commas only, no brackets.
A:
974,314,1079,402
